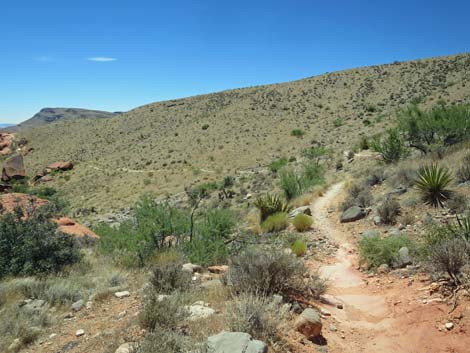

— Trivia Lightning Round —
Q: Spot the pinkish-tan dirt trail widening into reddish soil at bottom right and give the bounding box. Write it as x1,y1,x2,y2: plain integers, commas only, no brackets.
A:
311,183,470,353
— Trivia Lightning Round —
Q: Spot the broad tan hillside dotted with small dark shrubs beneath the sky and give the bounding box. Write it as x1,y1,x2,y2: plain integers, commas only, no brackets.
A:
21,54,470,212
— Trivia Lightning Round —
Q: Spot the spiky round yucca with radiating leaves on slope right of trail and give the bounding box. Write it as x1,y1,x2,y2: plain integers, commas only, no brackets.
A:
416,164,452,207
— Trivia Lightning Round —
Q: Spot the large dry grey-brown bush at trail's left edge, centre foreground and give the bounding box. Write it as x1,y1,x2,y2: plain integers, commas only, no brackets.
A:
226,248,306,295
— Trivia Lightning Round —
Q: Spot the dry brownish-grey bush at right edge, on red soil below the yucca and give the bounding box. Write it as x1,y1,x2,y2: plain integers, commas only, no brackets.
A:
429,237,470,284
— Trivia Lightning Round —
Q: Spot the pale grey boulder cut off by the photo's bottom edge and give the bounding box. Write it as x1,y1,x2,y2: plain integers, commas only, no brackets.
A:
207,332,268,353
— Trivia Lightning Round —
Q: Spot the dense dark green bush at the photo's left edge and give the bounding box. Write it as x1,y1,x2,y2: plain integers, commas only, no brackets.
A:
0,207,81,278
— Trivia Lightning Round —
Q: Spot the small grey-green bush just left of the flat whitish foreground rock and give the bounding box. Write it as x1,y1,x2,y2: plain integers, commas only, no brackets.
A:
139,291,189,332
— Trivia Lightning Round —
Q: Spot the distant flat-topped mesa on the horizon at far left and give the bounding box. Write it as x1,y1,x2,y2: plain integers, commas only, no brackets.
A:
9,108,118,130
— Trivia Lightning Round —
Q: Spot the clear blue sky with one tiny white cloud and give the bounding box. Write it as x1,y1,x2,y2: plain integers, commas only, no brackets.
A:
0,0,470,122
